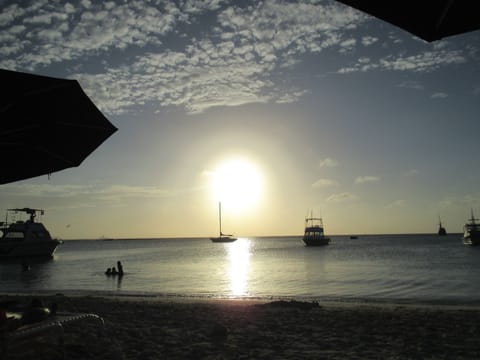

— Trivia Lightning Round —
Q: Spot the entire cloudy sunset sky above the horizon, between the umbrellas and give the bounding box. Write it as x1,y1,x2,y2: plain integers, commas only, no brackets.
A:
0,0,480,240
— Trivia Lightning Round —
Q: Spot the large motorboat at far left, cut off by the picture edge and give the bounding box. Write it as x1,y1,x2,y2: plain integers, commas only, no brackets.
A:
0,208,61,258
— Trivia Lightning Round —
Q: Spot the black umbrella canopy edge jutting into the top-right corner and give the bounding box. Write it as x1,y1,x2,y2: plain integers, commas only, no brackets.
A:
338,0,480,42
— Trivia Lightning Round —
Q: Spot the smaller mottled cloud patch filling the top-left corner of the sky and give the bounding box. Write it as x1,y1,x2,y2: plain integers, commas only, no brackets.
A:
0,0,184,70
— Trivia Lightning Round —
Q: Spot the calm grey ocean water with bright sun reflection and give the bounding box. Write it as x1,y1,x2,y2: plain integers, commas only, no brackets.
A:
0,234,480,305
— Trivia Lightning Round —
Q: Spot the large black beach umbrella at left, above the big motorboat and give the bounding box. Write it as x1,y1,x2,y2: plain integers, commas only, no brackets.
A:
0,69,117,184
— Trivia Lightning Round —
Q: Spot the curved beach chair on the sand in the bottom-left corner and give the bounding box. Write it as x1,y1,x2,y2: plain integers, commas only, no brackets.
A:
0,312,105,360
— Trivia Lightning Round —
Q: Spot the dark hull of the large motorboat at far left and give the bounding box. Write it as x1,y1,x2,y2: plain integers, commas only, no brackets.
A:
0,240,60,258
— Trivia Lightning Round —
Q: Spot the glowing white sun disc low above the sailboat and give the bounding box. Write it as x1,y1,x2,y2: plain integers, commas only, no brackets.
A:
211,159,262,212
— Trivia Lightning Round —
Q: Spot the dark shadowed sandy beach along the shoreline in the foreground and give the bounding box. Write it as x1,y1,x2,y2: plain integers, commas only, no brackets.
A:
0,294,480,360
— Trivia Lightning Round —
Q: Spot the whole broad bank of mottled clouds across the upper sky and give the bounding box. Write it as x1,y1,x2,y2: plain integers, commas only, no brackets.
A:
0,0,365,114
